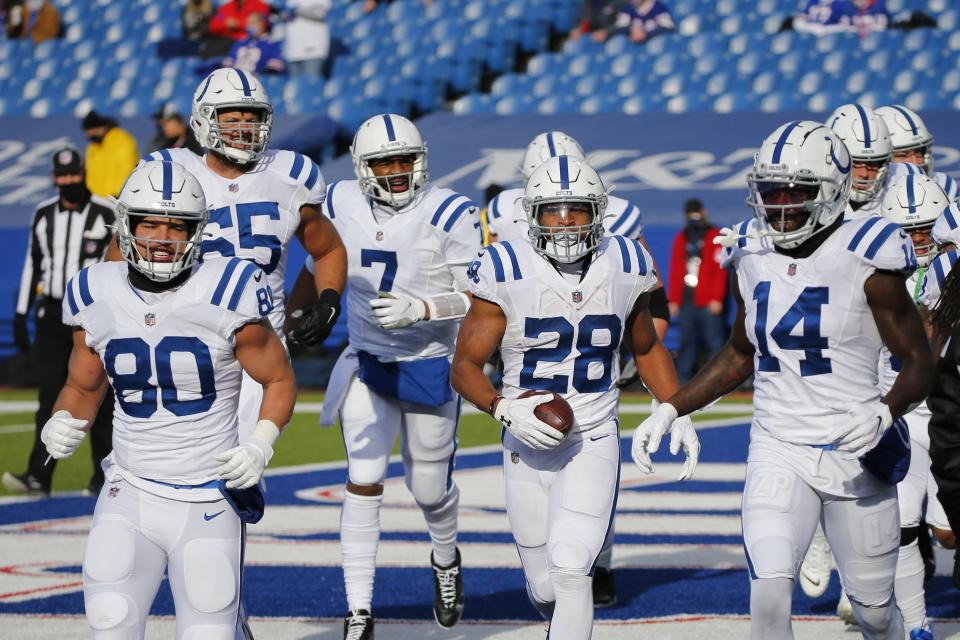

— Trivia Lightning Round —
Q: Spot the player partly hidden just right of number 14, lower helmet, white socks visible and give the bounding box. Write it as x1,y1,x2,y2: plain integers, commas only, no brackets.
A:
880,175,952,640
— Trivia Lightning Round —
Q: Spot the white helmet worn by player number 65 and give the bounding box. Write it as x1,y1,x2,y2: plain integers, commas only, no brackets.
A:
190,69,273,164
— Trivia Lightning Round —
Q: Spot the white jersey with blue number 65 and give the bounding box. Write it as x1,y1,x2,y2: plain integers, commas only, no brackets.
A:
149,149,326,335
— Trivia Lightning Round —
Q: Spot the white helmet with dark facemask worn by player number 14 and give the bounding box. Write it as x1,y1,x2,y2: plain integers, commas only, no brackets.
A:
747,120,853,249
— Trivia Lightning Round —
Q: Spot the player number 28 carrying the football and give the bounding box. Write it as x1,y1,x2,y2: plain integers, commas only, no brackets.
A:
451,156,700,640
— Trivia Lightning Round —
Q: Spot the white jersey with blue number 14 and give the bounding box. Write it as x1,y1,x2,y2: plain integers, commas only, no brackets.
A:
724,216,917,445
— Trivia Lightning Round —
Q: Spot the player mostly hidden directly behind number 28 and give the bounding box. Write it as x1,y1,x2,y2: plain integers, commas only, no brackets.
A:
485,131,670,608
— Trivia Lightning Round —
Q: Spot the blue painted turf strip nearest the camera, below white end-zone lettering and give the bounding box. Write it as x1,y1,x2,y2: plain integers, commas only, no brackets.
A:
7,558,960,621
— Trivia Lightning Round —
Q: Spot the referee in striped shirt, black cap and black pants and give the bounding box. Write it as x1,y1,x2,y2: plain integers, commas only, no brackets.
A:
2,147,119,495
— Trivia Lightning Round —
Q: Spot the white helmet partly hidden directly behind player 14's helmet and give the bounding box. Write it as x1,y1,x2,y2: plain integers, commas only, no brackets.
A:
827,104,893,202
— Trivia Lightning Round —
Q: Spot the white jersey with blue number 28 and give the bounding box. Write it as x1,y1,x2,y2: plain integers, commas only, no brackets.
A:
468,236,657,431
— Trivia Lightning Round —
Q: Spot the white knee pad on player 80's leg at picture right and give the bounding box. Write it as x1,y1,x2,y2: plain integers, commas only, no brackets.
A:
183,539,240,613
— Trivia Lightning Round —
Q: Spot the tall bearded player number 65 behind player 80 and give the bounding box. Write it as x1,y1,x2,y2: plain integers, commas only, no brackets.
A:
149,69,347,435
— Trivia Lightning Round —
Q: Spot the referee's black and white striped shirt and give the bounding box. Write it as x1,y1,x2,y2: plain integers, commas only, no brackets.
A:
17,196,115,314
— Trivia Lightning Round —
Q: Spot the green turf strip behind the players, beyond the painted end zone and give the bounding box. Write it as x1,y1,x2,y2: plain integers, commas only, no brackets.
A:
0,390,749,495
